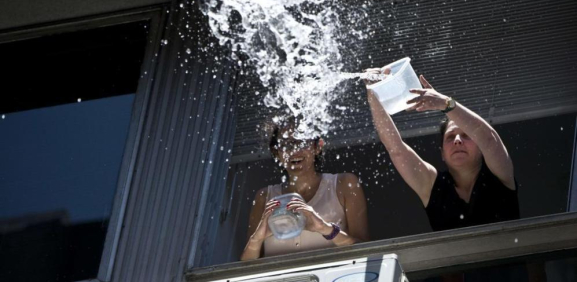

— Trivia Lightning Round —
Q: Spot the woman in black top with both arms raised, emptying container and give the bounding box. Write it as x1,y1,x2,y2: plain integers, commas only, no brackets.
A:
365,62,519,231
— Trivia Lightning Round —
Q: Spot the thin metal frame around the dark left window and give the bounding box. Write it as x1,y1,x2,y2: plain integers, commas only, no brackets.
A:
0,3,170,282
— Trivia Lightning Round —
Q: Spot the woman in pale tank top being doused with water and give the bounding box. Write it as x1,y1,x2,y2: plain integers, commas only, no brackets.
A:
241,119,369,260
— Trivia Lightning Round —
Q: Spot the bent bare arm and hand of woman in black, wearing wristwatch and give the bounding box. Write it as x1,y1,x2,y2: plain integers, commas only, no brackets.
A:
411,75,515,190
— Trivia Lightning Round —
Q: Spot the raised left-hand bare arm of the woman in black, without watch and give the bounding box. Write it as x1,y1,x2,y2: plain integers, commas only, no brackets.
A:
367,69,437,207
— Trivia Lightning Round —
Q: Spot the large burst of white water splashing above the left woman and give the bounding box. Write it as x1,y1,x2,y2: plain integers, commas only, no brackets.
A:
203,0,366,139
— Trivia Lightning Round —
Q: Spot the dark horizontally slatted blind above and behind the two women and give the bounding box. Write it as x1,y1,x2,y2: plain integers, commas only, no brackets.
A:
233,0,577,163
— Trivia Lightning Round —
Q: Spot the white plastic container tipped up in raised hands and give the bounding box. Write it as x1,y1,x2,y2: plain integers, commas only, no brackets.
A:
367,57,422,115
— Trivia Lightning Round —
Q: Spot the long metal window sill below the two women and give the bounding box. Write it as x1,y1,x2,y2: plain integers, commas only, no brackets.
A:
186,212,577,282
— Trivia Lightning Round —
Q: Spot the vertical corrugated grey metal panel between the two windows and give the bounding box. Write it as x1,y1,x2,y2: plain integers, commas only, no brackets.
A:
112,1,235,282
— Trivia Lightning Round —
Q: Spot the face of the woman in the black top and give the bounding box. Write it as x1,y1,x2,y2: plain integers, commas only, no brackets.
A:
442,121,483,168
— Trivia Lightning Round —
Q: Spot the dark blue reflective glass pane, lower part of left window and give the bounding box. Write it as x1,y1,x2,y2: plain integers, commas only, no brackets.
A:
0,94,134,281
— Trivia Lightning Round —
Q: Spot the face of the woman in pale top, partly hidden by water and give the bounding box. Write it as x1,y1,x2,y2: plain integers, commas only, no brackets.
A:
276,129,320,175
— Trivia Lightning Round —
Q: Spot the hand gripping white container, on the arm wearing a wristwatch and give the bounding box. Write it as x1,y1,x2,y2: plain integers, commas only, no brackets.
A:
407,75,450,112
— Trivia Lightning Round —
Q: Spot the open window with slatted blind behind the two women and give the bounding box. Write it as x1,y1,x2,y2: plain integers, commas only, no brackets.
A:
188,1,577,272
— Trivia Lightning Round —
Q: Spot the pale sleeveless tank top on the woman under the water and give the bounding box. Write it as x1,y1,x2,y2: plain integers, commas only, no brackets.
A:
264,173,348,257
